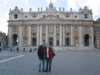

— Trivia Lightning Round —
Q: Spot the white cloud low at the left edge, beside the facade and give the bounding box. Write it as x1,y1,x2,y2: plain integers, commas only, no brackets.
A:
0,13,9,33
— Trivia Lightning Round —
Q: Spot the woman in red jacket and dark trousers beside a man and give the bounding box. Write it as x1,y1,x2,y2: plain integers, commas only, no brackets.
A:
45,43,55,72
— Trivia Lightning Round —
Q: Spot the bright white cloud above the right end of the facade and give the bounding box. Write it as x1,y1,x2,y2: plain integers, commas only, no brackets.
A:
67,0,100,16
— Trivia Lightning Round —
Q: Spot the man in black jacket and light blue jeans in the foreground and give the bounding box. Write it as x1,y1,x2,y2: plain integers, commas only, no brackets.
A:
37,42,46,72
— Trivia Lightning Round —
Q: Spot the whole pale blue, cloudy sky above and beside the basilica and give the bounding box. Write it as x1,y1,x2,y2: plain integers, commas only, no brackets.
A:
0,0,100,34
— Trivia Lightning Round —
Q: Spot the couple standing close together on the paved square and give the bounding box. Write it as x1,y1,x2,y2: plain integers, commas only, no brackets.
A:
37,42,55,72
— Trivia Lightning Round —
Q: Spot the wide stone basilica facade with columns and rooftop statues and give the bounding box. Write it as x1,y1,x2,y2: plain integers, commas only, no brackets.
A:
8,3,94,48
